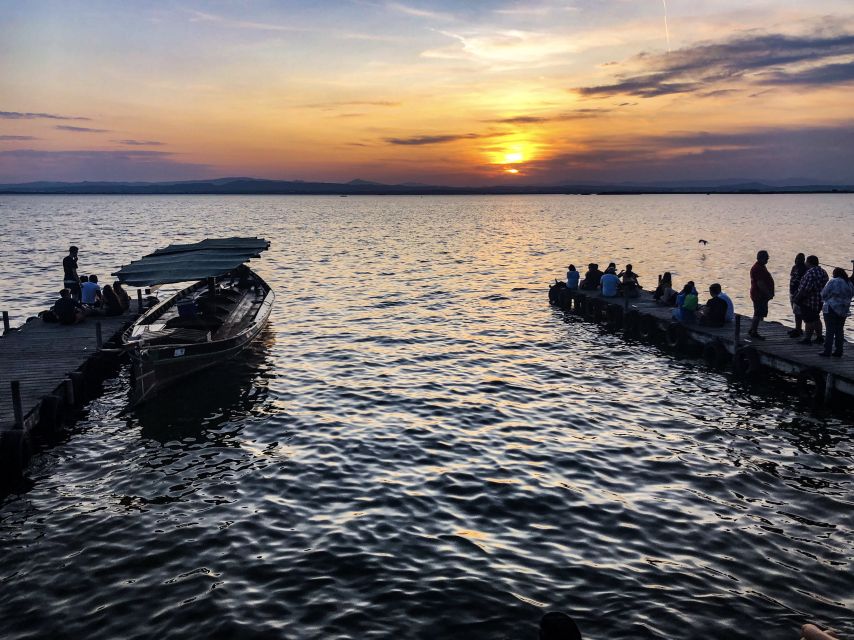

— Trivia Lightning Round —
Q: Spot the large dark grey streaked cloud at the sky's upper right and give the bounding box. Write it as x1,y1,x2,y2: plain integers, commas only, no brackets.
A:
575,33,854,98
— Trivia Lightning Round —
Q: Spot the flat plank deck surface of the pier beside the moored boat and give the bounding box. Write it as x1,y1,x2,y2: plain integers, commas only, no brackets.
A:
0,306,136,430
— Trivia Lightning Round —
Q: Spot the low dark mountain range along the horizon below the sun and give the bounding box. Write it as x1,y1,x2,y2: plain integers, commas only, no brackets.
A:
0,178,854,196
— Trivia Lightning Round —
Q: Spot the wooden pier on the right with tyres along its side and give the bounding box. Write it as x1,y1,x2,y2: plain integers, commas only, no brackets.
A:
549,286,854,403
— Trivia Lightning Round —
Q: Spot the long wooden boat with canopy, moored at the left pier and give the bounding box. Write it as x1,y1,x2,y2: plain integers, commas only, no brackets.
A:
113,238,275,404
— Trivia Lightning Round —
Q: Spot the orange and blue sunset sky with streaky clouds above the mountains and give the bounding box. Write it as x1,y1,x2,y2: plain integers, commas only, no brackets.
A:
0,0,854,185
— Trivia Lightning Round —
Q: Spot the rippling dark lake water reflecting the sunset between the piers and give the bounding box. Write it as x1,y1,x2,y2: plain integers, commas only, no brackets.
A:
0,195,854,640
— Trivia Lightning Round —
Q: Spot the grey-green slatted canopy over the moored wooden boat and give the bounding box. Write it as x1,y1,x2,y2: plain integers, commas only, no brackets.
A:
113,238,270,287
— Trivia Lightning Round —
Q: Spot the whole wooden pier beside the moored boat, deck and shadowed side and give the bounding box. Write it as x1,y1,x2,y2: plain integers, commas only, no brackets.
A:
0,304,137,480
